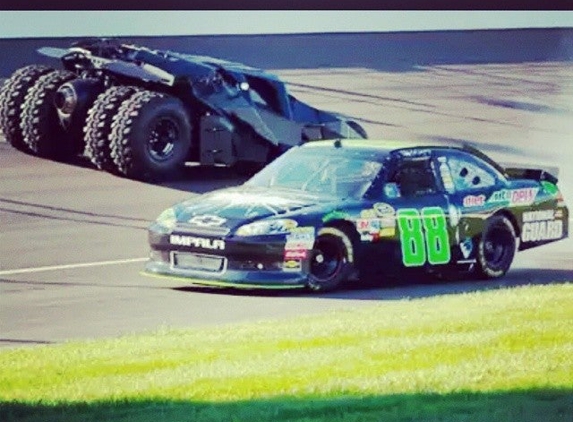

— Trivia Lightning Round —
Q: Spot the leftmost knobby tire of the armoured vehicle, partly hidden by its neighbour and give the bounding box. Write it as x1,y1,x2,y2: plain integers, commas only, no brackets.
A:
0,65,53,152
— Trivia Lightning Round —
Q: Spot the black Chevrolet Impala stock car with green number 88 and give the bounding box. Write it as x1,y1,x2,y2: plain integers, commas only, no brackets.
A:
146,140,569,291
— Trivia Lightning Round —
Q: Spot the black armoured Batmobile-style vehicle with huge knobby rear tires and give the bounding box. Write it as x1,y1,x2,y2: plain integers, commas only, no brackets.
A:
0,39,366,180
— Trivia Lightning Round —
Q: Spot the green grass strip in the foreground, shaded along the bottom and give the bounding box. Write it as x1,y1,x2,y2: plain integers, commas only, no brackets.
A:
0,283,573,422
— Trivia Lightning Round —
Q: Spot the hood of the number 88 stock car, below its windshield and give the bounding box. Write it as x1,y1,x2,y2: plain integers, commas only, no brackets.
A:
176,186,337,229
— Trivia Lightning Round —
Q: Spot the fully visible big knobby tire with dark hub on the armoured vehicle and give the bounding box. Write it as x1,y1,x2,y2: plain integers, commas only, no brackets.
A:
110,90,192,181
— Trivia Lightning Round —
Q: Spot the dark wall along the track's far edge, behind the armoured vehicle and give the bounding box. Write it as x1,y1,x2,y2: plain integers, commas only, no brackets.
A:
0,28,573,78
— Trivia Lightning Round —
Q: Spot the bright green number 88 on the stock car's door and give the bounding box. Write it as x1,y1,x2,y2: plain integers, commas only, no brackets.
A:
396,207,450,267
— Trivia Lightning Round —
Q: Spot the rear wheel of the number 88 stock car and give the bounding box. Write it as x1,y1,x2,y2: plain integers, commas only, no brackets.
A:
475,215,516,279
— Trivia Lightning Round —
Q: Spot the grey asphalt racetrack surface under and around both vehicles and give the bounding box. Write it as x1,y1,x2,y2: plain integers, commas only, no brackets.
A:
0,40,573,347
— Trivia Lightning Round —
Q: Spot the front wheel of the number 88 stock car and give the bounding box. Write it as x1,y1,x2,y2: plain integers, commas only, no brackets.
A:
307,227,355,292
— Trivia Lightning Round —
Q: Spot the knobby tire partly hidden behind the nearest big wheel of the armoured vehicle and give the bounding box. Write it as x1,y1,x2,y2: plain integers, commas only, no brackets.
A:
84,85,138,173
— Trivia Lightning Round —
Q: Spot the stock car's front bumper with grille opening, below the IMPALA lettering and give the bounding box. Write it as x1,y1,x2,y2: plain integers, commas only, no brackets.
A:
144,232,309,289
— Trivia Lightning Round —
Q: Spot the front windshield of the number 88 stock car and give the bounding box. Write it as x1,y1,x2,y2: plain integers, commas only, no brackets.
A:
246,148,382,199
